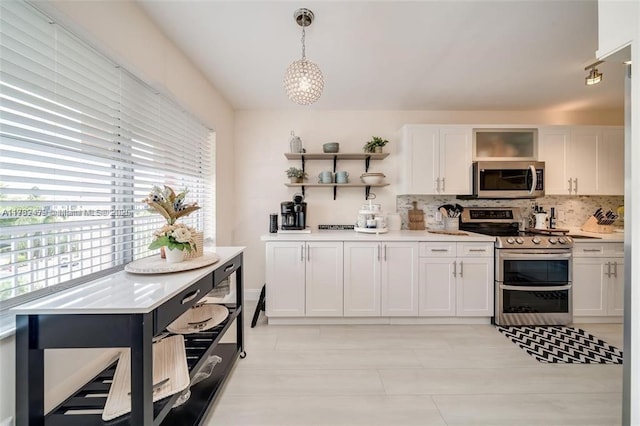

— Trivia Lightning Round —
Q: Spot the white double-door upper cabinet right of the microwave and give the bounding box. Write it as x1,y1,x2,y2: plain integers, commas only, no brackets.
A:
539,126,624,195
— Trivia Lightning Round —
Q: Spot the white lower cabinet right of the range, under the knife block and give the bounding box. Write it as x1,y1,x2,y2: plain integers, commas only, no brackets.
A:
573,243,624,317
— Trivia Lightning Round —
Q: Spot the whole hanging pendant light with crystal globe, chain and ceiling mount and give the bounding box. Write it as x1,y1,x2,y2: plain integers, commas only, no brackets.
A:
284,9,324,105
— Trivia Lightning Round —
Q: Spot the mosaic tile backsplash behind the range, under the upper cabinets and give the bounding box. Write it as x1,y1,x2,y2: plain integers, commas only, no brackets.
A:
396,195,624,229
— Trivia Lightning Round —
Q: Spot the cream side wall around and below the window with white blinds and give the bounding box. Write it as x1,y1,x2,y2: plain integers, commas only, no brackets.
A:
0,0,234,423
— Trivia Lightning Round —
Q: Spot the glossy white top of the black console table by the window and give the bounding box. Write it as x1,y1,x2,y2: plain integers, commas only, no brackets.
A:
10,247,244,314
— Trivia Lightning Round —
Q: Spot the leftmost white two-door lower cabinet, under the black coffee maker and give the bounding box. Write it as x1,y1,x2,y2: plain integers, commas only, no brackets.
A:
265,241,343,317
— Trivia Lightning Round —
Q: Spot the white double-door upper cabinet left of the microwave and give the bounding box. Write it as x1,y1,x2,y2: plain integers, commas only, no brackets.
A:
400,124,472,195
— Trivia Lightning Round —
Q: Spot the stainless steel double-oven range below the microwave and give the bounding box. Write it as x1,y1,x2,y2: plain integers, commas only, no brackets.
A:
460,207,573,325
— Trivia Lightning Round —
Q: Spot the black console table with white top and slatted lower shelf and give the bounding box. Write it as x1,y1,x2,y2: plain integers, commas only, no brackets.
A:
13,247,245,426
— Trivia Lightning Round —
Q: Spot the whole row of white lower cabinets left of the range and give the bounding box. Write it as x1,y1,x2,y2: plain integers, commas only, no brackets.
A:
266,241,494,318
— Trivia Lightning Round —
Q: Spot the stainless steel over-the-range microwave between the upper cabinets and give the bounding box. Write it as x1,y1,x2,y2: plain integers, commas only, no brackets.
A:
473,161,544,198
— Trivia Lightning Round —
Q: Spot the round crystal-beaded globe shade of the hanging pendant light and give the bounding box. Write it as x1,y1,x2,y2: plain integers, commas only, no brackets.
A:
284,58,324,105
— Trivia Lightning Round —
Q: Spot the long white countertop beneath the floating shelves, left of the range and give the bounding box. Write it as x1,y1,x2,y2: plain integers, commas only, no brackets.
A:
260,230,496,242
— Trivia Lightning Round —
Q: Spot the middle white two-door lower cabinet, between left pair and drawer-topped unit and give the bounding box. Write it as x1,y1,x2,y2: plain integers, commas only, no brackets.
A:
344,241,418,317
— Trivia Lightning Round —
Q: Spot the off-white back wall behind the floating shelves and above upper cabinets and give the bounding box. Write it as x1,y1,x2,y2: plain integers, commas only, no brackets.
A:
233,108,624,294
